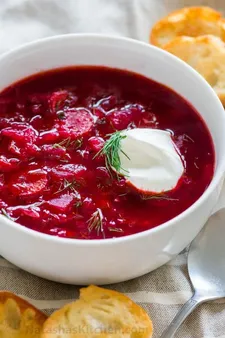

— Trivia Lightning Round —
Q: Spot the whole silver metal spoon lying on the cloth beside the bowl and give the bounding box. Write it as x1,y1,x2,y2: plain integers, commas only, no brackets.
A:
161,209,225,338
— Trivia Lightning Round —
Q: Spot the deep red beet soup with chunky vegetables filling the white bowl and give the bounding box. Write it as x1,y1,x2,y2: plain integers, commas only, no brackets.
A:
0,66,215,239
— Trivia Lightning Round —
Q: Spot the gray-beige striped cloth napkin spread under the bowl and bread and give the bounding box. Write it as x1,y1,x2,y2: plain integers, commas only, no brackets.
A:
0,0,225,338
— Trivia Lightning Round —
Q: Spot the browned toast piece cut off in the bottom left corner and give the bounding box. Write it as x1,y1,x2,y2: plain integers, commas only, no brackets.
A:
0,291,47,338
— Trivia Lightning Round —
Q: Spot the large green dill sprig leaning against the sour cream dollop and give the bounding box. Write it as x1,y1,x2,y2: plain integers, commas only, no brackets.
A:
94,131,130,176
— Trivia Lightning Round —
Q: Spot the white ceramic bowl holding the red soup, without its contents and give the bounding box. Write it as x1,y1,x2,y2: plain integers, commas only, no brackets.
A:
0,34,225,285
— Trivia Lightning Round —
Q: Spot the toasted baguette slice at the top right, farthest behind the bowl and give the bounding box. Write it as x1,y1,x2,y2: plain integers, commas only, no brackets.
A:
150,6,225,48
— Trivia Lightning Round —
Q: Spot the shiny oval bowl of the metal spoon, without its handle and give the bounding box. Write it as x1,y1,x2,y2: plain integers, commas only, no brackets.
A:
188,209,225,299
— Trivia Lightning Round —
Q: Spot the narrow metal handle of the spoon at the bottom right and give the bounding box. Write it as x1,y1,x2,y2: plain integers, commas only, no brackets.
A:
161,295,201,338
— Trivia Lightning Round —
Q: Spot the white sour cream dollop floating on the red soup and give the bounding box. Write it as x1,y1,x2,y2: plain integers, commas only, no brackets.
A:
119,128,184,193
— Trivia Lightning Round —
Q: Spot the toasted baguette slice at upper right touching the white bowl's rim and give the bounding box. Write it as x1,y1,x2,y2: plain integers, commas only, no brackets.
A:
164,35,225,106
